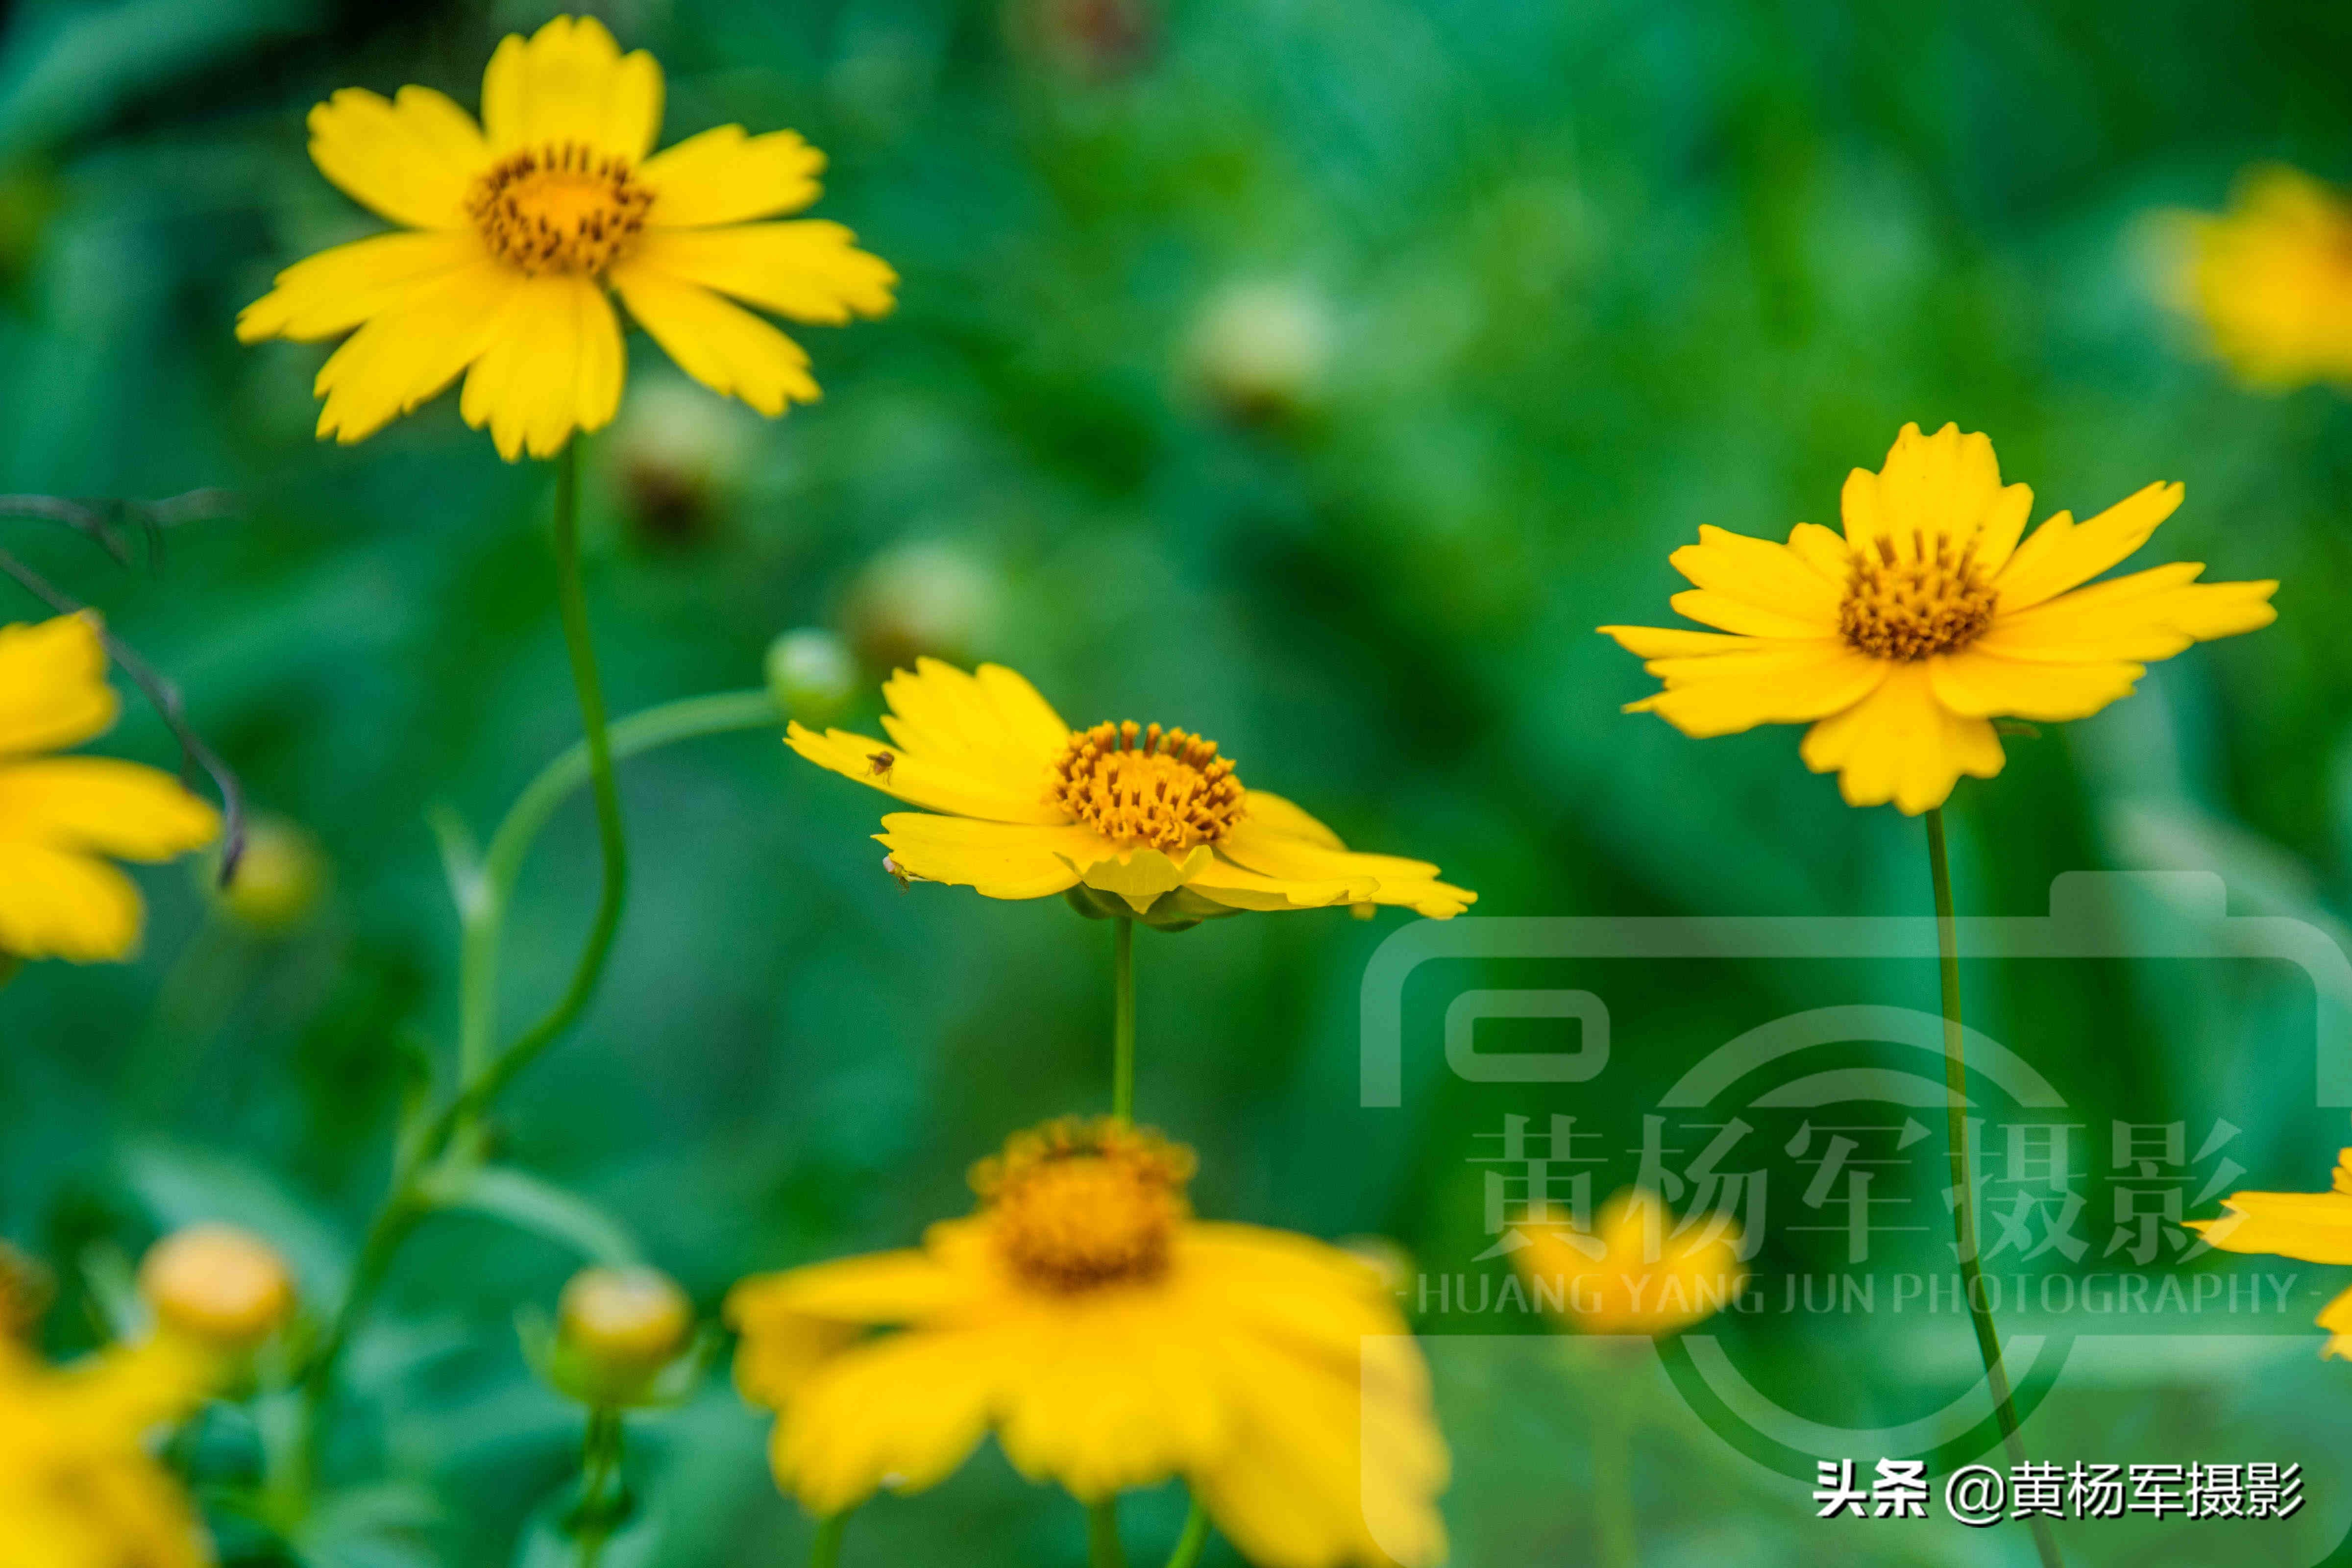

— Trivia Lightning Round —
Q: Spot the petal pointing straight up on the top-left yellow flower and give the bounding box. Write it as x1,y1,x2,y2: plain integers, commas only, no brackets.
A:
482,17,661,162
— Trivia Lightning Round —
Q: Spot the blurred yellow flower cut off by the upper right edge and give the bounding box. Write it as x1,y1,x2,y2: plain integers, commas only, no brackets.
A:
2166,167,2352,390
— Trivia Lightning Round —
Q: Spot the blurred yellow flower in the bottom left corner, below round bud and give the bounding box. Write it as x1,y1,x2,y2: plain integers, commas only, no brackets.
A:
0,1340,212,1568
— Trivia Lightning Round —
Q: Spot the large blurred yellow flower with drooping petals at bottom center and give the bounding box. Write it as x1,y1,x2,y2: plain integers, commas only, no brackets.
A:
727,1119,1446,1568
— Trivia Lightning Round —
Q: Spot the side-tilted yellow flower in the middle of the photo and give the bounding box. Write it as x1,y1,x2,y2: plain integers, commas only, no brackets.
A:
788,658,1477,919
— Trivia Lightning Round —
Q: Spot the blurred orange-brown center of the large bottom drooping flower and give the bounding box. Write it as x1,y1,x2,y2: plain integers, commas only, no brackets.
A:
971,1117,1193,1293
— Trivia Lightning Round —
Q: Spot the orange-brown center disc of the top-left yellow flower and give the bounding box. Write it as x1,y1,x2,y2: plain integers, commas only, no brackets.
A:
466,141,654,275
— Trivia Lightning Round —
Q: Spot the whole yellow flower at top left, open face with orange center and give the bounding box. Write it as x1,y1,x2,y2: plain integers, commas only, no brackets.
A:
238,17,896,461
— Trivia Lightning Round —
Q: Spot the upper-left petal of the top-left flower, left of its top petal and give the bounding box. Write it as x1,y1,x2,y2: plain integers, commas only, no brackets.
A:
311,87,489,228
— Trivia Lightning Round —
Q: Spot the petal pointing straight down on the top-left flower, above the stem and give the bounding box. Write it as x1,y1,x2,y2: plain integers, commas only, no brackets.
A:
459,272,626,463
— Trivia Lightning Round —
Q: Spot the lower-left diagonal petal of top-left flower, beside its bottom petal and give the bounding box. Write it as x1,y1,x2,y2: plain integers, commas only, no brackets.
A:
315,256,529,447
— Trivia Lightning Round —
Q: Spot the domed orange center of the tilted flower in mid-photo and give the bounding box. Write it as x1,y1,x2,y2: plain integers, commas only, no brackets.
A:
1047,719,1242,851
